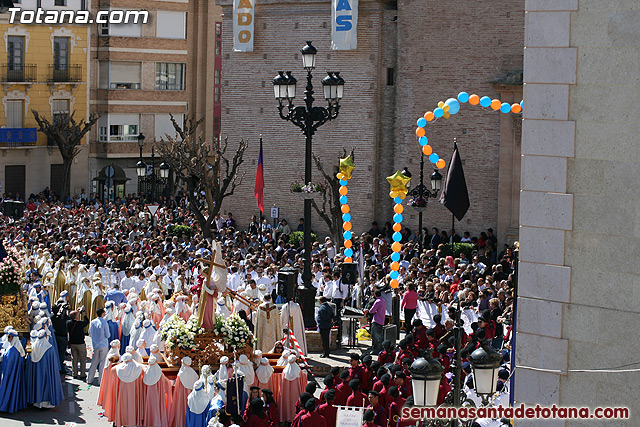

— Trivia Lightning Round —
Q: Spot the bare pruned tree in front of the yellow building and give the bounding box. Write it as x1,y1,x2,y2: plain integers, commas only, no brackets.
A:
31,110,100,200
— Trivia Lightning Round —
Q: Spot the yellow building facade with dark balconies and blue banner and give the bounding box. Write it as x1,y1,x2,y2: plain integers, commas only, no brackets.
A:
0,5,90,201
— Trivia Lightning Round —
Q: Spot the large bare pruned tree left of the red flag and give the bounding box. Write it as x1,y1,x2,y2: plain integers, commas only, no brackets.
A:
158,115,248,237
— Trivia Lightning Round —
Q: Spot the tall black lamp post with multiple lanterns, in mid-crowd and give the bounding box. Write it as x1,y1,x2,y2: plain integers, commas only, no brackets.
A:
273,41,345,327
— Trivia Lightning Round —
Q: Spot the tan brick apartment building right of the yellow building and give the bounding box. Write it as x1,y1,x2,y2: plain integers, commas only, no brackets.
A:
89,0,222,199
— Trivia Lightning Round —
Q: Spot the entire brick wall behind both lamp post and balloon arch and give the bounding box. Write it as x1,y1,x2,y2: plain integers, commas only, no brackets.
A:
217,0,524,242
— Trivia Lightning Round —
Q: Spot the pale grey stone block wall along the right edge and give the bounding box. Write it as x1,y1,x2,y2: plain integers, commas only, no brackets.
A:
515,0,640,426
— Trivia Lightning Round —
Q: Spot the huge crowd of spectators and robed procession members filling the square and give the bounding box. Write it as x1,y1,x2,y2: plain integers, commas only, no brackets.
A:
0,192,515,427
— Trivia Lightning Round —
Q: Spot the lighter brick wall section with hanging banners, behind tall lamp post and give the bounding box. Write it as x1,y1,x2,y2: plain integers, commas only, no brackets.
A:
222,1,384,237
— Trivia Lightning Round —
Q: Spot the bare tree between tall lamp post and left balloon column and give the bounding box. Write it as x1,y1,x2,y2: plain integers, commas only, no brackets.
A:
311,147,355,248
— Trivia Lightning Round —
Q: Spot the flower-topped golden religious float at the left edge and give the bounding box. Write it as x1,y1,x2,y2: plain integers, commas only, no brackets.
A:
0,248,29,332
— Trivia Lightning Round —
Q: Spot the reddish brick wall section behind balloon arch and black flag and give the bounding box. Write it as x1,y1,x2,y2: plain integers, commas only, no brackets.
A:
395,0,524,235
